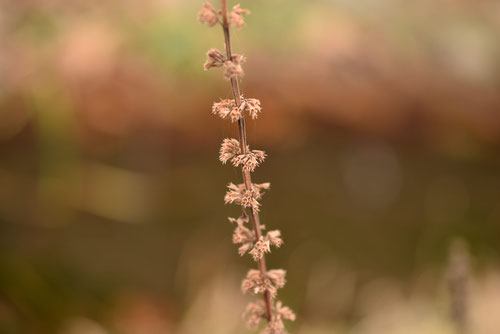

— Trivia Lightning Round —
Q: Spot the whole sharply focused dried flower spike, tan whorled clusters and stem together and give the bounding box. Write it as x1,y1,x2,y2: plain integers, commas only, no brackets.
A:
198,0,295,334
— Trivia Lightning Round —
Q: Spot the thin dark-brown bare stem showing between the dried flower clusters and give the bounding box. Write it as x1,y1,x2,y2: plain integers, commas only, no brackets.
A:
221,0,272,321
